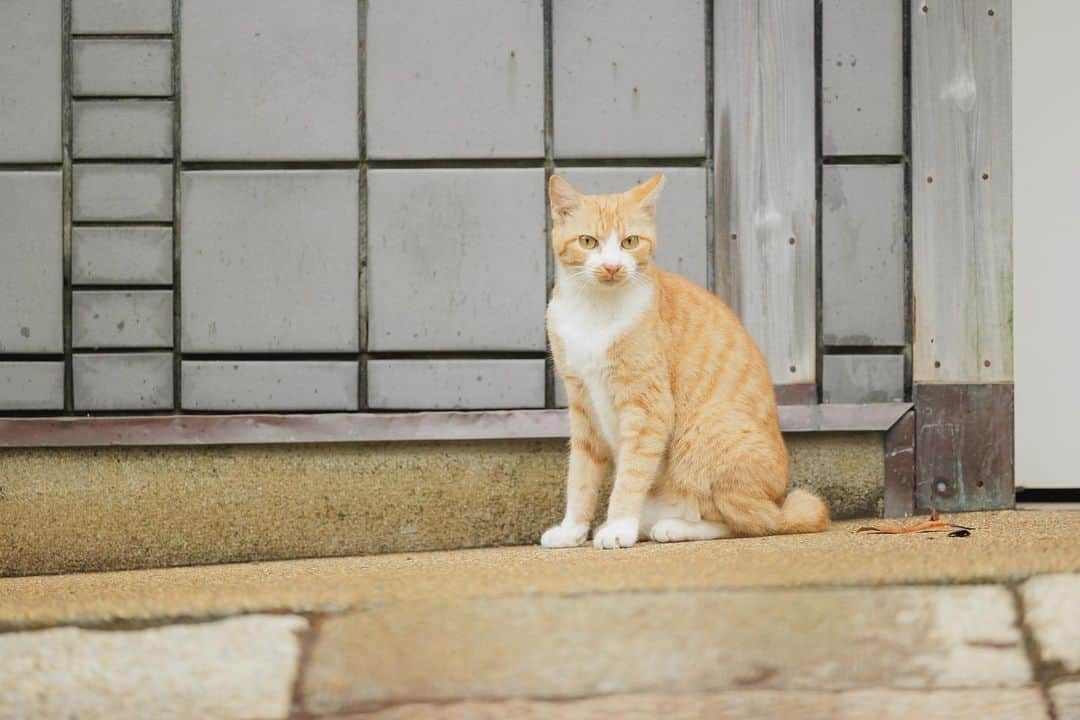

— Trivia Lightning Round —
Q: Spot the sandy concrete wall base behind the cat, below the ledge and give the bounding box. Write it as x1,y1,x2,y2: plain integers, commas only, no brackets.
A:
0,433,883,575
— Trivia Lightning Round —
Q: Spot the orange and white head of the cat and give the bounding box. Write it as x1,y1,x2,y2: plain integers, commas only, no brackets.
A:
548,175,664,287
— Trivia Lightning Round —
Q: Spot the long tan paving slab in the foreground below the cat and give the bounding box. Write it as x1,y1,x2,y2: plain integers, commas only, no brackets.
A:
301,586,1032,715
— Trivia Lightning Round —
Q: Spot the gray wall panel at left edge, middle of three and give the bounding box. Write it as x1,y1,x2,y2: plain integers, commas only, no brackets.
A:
0,172,64,353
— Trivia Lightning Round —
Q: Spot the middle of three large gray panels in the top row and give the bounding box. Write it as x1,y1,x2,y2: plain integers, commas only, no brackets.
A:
366,0,543,158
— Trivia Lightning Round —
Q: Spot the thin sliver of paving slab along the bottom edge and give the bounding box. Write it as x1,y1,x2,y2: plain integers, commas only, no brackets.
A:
334,688,1045,720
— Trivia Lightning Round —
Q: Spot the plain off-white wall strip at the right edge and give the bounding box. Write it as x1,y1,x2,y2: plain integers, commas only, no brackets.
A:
1013,0,1080,488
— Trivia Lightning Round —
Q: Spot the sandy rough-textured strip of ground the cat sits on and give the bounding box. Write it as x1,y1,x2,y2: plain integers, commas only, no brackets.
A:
0,509,1080,627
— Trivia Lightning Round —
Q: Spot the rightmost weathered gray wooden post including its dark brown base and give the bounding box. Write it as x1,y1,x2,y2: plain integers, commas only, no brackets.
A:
912,0,1014,511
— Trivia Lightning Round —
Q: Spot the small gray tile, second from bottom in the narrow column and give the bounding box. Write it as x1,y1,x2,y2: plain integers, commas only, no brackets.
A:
71,290,173,348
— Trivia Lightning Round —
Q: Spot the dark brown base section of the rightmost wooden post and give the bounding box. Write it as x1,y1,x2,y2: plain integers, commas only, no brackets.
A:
915,383,1015,512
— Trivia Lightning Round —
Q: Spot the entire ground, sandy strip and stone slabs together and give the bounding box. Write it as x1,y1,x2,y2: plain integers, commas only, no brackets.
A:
0,513,1080,719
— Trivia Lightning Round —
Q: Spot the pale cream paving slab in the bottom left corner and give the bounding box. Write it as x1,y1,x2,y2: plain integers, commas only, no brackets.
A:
0,615,308,720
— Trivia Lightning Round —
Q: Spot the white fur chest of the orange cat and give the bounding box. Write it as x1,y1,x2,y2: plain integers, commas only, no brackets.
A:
548,285,652,451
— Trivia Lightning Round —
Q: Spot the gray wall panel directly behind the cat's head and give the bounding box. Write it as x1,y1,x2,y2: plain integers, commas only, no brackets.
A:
556,167,708,287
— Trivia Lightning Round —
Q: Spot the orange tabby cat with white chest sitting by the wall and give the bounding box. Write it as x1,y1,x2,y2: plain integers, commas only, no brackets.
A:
540,175,828,547
